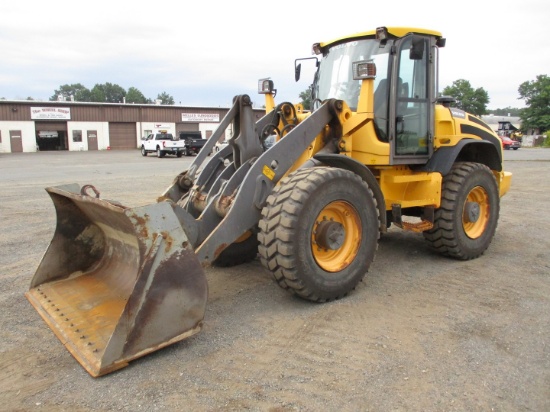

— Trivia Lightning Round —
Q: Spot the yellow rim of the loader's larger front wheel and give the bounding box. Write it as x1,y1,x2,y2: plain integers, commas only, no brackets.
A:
311,200,361,272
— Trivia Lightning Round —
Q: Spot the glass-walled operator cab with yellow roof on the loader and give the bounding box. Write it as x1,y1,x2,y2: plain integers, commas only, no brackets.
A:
312,27,444,164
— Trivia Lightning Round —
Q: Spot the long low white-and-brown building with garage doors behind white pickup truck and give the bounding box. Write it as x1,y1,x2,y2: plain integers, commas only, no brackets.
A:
0,100,265,153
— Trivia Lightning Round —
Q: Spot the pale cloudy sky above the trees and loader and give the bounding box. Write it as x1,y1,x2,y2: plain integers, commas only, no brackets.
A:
0,0,550,109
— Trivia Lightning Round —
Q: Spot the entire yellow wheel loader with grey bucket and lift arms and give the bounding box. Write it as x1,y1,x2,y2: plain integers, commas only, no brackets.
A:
26,27,511,377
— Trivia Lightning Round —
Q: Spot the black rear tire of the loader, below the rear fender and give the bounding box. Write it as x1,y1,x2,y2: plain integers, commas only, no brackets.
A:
423,162,500,260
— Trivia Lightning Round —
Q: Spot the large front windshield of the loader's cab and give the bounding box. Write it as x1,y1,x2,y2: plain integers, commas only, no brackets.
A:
313,39,393,110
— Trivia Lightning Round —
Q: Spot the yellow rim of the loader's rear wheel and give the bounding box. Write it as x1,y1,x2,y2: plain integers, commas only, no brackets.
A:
462,186,491,239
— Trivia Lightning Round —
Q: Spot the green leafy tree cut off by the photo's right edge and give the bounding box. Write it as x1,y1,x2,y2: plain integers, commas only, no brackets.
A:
518,74,550,131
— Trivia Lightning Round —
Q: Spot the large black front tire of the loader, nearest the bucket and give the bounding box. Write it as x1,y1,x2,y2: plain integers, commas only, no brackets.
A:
258,167,379,302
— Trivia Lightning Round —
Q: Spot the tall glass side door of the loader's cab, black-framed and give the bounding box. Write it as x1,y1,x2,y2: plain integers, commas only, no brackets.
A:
389,34,435,164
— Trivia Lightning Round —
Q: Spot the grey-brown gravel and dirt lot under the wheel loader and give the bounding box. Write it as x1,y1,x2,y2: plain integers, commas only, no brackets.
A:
0,149,550,411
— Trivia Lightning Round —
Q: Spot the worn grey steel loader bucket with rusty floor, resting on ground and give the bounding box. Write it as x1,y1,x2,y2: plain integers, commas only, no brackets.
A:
26,184,208,377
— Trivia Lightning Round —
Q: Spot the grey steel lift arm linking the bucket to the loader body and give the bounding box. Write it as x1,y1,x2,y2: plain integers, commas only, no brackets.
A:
164,95,343,266
